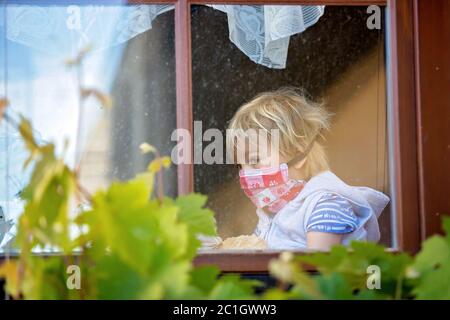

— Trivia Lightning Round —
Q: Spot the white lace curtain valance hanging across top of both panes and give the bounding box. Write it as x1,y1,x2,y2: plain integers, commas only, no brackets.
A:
0,5,324,69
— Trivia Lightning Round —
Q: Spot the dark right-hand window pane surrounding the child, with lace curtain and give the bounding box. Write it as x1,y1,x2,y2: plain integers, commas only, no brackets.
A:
191,5,392,245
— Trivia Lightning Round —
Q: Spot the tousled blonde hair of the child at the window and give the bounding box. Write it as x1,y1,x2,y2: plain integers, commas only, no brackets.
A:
227,87,331,179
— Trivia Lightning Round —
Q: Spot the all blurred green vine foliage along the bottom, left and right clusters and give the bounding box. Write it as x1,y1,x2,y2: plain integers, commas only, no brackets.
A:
0,114,450,299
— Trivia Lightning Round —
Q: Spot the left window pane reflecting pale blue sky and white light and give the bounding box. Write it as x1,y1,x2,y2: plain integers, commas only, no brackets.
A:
0,5,177,251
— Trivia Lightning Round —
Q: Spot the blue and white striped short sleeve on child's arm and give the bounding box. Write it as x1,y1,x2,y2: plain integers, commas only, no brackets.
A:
306,194,358,234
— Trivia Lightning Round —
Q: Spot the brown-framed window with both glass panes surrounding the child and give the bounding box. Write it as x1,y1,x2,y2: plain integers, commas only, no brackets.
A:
0,0,420,271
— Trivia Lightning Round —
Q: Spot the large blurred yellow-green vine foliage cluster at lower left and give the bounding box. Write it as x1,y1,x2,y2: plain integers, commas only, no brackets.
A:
0,119,256,299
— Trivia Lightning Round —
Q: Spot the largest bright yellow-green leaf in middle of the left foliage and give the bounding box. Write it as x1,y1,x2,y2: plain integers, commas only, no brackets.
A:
85,181,160,273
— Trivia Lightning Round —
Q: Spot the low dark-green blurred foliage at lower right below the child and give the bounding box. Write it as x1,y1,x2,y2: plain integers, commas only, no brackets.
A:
264,217,450,300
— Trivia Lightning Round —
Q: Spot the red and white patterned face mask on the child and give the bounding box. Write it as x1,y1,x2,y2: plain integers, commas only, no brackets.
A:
239,163,304,213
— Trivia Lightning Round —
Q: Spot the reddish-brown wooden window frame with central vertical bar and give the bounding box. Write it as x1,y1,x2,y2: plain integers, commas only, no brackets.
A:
0,0,426,273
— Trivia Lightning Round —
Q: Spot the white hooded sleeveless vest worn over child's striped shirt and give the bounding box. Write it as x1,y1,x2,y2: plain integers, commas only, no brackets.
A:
254,171,389,250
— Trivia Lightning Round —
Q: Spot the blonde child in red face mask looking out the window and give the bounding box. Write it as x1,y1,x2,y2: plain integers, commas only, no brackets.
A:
227,88,389,250
